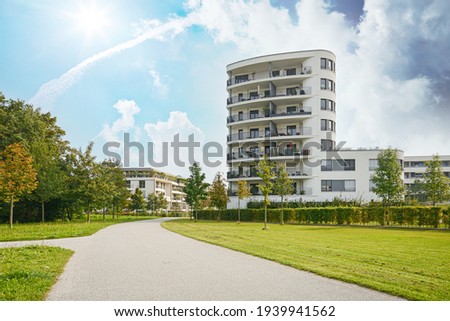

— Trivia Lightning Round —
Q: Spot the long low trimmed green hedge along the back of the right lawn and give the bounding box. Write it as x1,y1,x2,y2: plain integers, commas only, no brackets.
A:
194,206,450,228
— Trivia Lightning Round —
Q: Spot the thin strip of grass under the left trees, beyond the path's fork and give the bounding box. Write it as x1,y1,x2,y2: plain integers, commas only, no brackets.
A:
0,215,157,242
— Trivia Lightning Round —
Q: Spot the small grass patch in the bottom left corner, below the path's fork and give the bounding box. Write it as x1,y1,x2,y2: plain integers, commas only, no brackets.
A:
0,246,73,301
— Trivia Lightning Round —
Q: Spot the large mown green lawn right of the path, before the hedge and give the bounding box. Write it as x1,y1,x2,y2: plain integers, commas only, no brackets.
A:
163,220,450,300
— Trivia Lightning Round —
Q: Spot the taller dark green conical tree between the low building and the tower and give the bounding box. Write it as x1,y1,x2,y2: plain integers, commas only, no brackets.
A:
183,163,208,221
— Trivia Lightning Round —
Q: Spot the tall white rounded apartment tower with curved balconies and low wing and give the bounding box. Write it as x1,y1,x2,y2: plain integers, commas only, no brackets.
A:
227,50,450,208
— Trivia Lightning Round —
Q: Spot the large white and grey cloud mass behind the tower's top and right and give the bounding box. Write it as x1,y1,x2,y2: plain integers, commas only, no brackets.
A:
187,0,450,154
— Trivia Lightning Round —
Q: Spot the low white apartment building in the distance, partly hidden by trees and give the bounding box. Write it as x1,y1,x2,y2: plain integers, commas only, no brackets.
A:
122,168,188,211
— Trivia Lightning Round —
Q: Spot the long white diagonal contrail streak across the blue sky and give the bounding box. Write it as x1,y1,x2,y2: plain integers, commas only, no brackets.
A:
28,16,191,109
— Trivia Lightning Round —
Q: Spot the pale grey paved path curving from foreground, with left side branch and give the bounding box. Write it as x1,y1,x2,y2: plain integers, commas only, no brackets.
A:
0,219,399,301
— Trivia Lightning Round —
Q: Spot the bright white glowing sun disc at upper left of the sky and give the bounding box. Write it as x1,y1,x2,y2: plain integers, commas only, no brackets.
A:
70,3,111,38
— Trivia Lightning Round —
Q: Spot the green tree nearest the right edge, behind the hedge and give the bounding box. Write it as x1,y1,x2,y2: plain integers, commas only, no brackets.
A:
424,155,450,205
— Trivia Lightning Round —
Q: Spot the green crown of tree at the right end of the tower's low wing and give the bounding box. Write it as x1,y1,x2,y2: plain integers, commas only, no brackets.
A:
371,148,405,206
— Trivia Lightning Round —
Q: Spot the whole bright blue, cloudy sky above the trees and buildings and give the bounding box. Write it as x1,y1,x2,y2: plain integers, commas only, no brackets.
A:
0,0,450,180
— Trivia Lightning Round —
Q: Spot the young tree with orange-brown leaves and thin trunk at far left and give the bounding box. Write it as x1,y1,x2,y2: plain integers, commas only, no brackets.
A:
0,143,37,229
